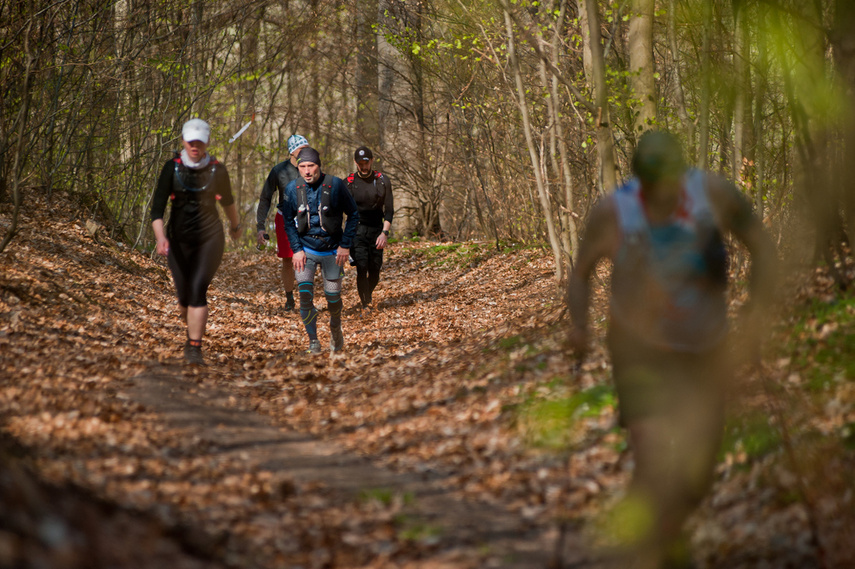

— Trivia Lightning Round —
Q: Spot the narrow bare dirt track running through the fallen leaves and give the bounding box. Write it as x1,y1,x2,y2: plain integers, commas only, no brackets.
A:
123,368,578,569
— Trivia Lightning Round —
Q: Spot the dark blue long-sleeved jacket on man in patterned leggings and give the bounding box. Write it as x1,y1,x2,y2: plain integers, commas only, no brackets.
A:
279,173,359,253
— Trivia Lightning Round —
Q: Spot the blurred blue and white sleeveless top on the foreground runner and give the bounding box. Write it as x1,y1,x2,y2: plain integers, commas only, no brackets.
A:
611,169,727,352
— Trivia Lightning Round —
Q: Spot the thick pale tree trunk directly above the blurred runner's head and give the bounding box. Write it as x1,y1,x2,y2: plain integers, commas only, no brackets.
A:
629,0,656,135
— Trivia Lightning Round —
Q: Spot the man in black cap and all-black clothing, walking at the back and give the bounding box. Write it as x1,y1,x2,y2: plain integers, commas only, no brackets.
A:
347,146,395,310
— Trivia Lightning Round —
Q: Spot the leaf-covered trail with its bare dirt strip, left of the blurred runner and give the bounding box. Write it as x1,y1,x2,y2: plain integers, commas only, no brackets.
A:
0,193,605,569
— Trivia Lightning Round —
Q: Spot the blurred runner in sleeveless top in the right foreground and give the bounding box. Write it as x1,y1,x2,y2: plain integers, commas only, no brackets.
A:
568,131,776,568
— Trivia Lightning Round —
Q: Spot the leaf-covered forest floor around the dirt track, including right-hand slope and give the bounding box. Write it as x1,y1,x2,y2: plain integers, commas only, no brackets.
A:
0,189,855,568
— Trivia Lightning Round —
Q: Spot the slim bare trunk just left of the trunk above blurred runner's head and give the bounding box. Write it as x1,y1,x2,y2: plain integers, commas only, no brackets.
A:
582,0,617,194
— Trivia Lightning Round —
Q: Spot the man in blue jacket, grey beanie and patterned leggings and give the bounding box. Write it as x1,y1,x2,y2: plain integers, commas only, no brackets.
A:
279,147,359,354
